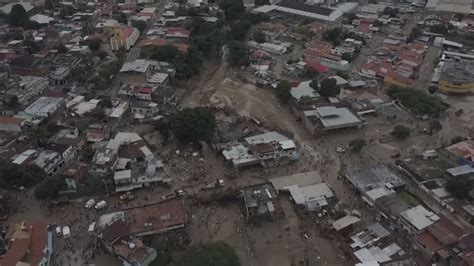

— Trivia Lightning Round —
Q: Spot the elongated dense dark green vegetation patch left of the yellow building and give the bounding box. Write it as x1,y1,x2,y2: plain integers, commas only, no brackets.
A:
387,87,449,117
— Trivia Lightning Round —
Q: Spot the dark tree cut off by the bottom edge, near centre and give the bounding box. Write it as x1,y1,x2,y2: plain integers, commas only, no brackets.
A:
175,241,240,266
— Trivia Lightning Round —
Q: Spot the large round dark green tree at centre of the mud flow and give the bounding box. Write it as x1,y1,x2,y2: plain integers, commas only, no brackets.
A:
170,107,216,143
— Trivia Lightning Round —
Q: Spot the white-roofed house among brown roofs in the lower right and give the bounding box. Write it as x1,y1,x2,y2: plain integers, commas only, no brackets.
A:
399,205,440,237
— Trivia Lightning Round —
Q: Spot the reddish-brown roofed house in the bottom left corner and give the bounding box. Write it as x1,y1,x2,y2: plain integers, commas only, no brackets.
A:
0,220,53,266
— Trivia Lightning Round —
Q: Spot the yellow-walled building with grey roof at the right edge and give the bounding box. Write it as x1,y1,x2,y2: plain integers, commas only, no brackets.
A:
438,61,474,94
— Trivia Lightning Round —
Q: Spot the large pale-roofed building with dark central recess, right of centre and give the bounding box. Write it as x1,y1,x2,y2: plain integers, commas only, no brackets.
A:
303,106,363,135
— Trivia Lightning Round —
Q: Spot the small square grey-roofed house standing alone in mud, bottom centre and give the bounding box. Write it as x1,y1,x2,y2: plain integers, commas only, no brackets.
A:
243,183,283,221
